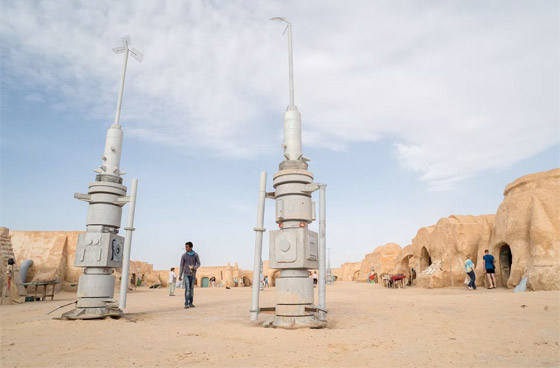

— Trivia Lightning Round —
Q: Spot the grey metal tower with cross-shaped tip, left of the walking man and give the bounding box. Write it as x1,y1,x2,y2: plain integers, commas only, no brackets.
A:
62,36,143,319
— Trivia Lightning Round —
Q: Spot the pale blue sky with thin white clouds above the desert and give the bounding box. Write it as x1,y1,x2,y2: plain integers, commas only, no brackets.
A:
0,0,560,269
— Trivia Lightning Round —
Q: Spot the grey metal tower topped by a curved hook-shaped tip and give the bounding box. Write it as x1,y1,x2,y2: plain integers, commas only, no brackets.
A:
251,18,326,328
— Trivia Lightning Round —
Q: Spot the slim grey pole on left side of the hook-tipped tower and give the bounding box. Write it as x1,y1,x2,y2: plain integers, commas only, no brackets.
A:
251,171,266,321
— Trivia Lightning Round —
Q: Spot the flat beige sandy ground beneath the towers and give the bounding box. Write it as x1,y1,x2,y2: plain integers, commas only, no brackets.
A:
0,282,560,367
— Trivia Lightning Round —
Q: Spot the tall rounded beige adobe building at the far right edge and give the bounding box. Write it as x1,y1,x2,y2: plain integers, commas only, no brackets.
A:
490,169,560,290
